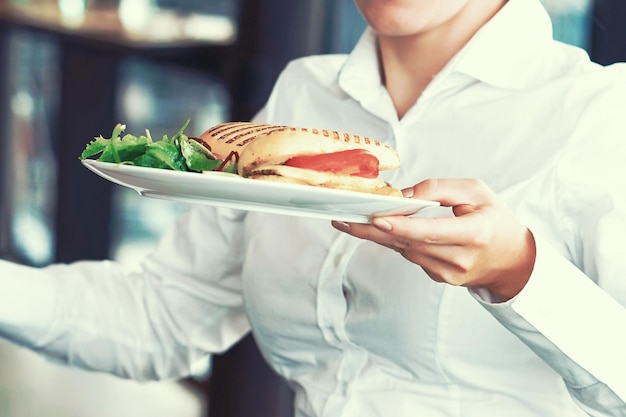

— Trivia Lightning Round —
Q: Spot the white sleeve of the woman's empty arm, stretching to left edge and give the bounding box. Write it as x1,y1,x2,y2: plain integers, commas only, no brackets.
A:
0,206,249,380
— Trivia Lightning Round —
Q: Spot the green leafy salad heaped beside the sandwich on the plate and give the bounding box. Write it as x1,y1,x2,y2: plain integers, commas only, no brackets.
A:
79,119,237,173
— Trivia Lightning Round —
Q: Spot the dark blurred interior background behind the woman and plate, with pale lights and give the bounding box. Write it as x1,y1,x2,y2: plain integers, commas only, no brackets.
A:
0,0,626,417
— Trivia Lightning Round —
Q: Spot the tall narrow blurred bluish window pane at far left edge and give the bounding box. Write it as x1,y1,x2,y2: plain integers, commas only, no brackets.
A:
0,32,57,265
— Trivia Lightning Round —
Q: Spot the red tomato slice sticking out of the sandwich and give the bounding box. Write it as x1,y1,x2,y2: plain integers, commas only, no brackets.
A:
284,149,379,178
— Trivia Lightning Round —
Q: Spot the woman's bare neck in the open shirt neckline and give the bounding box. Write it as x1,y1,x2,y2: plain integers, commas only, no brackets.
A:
378,0,506,118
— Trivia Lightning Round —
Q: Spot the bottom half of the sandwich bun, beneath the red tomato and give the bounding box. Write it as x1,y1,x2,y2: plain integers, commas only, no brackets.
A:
248,165,402,197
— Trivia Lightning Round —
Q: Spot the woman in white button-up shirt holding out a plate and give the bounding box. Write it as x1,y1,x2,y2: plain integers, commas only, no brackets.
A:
0,0,626,417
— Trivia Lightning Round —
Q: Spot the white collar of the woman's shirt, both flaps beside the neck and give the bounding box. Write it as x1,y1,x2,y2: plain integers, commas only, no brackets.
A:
338,0,552,102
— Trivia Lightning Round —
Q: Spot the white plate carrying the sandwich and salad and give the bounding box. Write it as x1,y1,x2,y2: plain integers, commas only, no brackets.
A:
82,160,439,223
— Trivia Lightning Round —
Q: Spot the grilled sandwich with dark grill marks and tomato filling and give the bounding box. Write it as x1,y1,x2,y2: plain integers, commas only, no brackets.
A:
197,122,402,197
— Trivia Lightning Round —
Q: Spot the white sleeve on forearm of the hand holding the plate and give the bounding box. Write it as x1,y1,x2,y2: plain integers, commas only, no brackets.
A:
472,236,626,416
